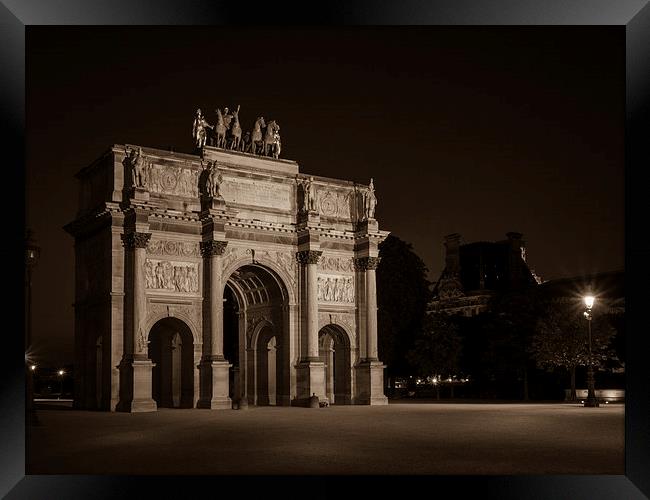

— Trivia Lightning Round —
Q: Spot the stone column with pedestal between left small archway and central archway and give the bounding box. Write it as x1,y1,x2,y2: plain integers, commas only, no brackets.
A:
196,240,232,409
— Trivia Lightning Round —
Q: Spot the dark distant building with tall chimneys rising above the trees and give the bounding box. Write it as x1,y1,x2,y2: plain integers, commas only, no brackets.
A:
428,232,542,316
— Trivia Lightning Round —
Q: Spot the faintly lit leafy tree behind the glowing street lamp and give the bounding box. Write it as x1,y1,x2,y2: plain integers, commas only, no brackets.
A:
530,303,616,401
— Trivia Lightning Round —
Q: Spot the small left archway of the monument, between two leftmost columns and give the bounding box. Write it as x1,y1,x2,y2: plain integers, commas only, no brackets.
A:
149,317,194,408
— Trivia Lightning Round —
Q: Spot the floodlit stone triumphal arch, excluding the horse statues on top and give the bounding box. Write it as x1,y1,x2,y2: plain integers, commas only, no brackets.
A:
65,128,388,412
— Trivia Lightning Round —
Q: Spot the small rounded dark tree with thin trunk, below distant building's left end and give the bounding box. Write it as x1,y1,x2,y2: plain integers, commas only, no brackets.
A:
407,314,462,399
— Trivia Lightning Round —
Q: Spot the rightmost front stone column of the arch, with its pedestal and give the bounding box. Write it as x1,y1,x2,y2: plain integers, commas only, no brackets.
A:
354,257,388,405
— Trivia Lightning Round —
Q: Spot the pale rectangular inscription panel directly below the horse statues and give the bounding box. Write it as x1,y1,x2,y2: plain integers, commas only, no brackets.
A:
221,177,294,211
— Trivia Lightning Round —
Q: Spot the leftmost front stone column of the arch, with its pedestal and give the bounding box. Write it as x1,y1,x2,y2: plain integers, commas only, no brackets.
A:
116,232,157,412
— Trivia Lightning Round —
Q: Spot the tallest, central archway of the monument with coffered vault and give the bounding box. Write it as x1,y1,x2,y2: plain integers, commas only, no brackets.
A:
224,263,291,406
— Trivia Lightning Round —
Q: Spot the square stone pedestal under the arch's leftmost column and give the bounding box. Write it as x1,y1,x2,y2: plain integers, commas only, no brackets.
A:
115,359,158,413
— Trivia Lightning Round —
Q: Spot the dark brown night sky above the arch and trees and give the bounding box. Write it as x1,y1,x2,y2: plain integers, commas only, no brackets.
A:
26,26,625,366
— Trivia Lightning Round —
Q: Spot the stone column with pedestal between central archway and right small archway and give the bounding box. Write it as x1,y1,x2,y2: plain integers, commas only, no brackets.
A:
294,250,326,406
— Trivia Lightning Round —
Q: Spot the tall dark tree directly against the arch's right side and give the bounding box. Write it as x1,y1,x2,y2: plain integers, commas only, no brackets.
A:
377,235,431,382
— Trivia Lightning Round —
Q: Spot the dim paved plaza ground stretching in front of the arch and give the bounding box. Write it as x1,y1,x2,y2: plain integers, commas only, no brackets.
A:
27,402,625,475
